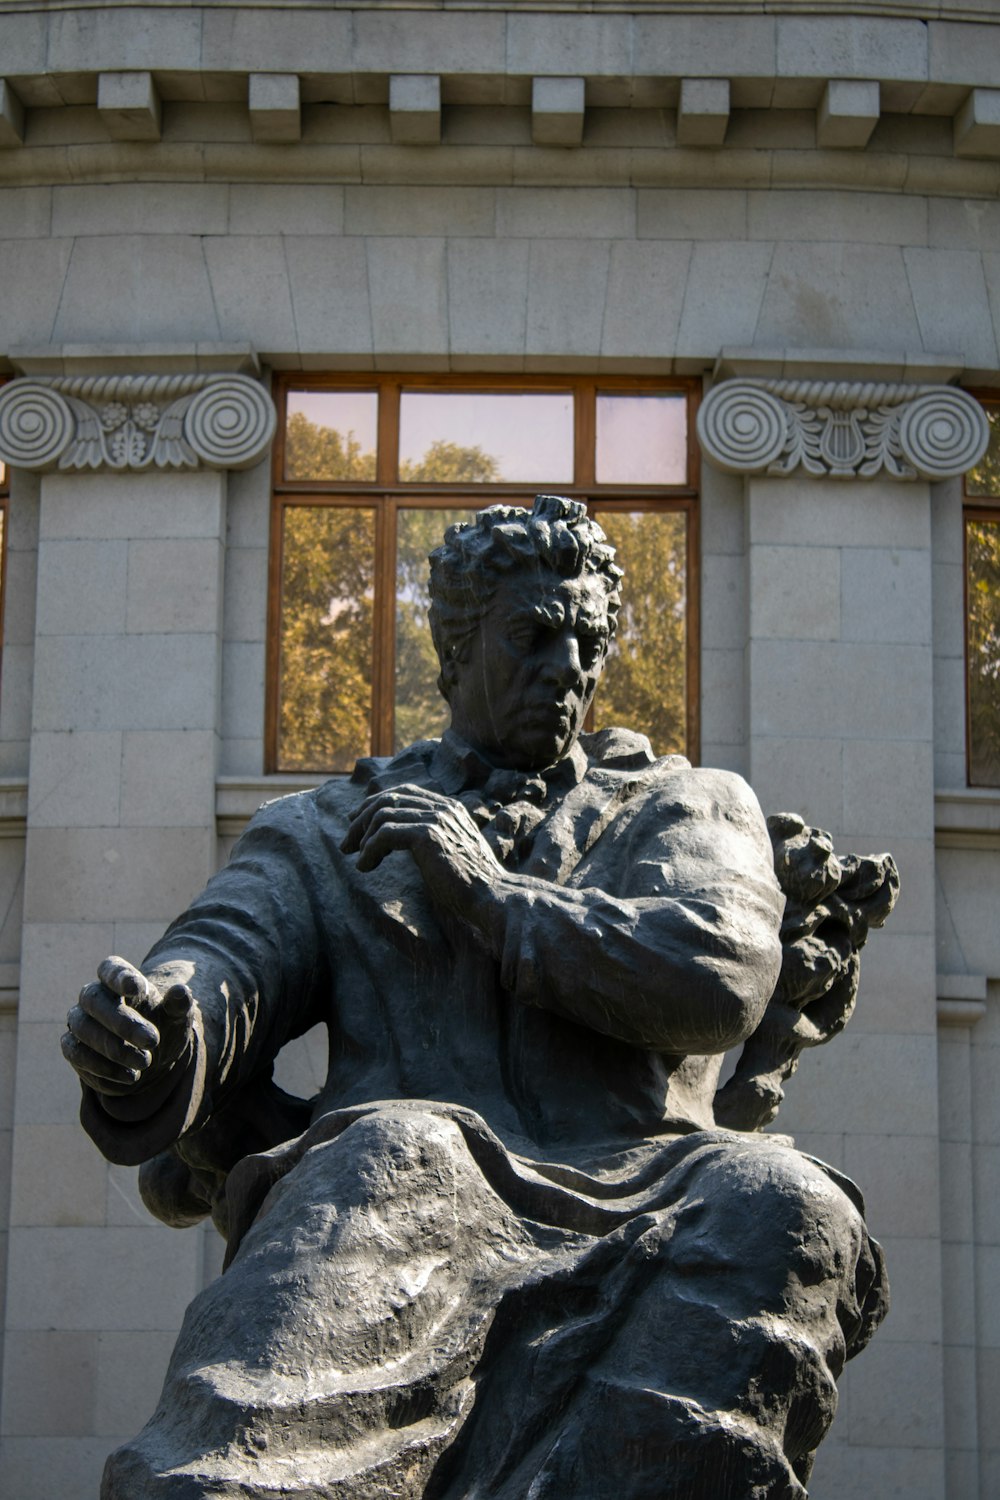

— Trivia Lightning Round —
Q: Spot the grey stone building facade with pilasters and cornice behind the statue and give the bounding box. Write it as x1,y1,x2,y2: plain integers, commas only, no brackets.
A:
0,0,1000,1500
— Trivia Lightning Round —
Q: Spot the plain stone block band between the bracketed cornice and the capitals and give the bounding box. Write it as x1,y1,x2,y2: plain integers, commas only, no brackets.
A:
0,179,1000,377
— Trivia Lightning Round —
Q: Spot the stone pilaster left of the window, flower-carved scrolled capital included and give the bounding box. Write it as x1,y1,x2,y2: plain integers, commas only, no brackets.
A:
0,360,274,1493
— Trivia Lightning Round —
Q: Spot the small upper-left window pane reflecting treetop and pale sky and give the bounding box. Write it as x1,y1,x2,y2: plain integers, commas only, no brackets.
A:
285,390,378,480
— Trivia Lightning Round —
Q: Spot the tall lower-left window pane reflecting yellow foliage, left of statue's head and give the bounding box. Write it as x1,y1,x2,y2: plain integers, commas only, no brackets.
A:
277,506,375,771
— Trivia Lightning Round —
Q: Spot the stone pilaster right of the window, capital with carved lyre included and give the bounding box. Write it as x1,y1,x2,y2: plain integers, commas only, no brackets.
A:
699,377,987,1494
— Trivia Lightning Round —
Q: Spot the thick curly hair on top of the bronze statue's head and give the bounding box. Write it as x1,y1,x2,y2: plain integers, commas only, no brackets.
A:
430,495,624,692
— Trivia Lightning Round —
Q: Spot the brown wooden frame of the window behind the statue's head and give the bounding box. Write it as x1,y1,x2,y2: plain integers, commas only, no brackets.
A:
264,371,702,774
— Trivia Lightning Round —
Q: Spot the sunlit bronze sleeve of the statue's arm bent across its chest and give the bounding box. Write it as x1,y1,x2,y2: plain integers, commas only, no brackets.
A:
490,771,784,1055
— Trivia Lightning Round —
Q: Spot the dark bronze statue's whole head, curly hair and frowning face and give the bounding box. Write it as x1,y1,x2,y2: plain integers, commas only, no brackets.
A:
430,495,622,770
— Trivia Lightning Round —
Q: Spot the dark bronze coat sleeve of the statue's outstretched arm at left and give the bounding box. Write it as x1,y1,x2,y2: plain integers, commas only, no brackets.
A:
81,794,333,1166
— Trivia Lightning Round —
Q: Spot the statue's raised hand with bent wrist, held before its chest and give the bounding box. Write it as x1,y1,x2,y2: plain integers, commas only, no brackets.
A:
343,785,504,911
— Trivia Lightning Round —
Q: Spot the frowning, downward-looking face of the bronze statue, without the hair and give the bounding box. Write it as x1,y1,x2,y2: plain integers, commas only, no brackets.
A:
448,566,609,771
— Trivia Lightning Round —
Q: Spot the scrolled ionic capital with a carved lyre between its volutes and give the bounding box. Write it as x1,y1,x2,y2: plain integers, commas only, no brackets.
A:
697,380,990,480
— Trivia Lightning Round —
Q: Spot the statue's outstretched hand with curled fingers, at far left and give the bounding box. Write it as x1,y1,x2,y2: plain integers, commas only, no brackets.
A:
61,957,193,1095
